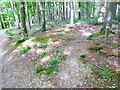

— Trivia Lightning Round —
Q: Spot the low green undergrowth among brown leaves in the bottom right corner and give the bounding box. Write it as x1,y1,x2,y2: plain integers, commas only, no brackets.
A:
91,66,118,88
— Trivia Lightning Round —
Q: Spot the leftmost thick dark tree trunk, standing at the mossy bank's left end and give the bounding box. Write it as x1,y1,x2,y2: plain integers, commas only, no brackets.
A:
20,0,28,36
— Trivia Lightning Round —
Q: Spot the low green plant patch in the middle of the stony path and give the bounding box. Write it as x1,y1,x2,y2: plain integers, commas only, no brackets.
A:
31,48,67,75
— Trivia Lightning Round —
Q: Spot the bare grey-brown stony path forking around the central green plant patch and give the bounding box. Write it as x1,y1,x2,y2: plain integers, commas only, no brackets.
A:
1,24,119,88
